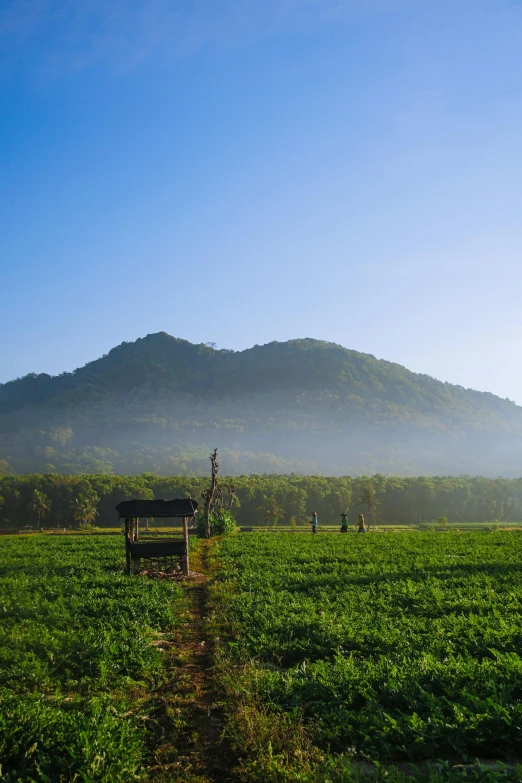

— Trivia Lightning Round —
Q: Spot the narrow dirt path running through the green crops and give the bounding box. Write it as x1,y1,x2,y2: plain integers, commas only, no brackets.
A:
149,541,234,783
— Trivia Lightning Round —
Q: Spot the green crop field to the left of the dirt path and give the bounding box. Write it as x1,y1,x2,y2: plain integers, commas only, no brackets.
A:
0,535,186,783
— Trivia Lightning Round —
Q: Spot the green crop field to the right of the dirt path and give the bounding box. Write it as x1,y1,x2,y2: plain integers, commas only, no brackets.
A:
211,531,522,780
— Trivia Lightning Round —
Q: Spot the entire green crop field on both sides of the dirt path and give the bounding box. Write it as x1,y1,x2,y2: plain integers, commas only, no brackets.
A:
0,531,522,783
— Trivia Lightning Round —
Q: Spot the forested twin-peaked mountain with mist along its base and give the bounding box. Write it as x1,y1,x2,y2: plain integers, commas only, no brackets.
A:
0,332,522,476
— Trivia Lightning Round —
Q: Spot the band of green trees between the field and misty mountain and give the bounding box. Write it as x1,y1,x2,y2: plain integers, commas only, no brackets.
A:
0,473,522,529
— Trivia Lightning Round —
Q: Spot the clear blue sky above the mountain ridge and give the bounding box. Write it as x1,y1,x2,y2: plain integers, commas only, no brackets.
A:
0,0,522,404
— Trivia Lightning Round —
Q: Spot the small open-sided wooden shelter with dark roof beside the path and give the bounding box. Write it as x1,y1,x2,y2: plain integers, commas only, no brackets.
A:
116,498,198,574
